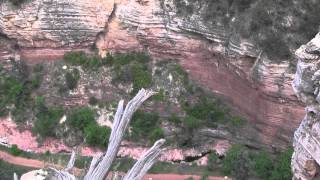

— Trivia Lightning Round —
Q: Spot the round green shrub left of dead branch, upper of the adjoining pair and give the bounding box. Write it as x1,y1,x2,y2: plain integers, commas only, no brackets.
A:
66,107,95,132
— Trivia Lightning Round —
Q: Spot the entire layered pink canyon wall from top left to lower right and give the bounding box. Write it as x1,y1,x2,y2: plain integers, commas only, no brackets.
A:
0,0,304,149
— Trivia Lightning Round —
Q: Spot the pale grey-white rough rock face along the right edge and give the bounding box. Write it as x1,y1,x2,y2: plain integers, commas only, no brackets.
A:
291,33,320,180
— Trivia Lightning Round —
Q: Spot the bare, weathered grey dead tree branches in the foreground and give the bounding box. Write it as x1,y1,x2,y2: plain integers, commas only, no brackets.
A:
51,89,165,180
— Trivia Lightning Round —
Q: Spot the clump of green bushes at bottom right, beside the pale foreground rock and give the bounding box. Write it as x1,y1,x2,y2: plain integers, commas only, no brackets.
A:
215,145,293,180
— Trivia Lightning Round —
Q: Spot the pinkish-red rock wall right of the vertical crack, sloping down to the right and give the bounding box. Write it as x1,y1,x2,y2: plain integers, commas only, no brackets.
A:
97,0,303,148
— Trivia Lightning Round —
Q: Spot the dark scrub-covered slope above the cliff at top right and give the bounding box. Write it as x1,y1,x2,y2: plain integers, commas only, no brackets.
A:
174,0,320,60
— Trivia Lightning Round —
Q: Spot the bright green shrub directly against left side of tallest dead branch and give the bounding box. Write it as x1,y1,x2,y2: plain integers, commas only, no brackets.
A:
84,123,111,148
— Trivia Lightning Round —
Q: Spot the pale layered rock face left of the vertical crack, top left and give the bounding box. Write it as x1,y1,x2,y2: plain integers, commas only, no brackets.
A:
0,0,114,48
